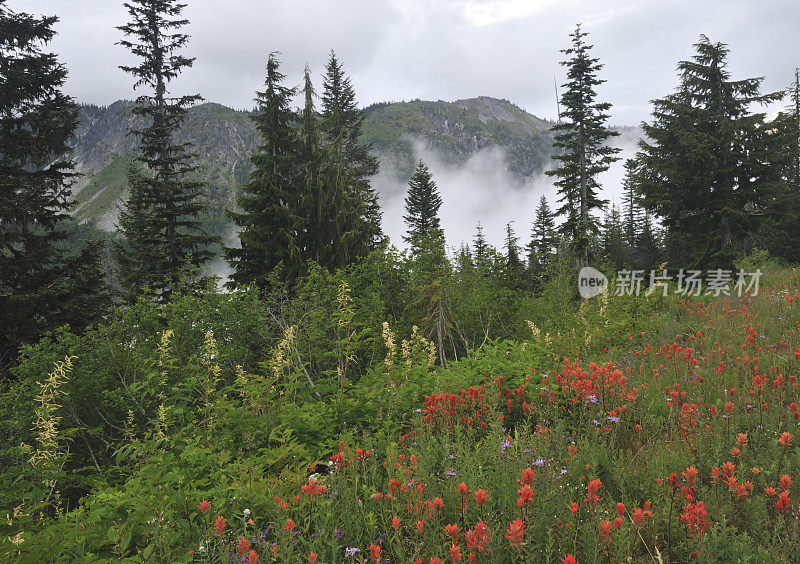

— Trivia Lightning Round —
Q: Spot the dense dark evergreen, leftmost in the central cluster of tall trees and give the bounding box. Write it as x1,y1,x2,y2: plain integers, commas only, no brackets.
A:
225,53,299,287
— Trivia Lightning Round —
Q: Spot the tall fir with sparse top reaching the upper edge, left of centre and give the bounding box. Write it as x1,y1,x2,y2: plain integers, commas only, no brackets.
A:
117,0,213,296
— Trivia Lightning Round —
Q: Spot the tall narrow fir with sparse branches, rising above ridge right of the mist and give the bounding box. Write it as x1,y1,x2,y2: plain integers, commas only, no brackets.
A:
546,25,619,266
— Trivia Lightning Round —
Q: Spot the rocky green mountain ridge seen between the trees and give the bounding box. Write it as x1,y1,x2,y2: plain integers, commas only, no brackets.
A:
67,97,552,236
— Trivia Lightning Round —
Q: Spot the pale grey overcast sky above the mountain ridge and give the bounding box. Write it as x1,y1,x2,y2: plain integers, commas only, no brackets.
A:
7,0,800,125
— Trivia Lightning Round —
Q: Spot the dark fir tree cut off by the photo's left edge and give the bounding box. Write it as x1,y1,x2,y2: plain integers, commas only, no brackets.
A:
0,0,105,376
